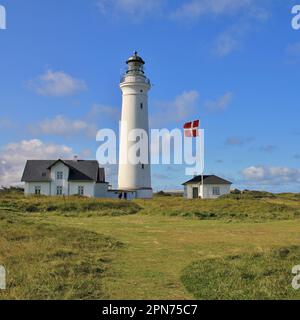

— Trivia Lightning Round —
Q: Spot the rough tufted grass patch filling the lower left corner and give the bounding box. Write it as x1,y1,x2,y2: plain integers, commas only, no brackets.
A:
0,212,123,300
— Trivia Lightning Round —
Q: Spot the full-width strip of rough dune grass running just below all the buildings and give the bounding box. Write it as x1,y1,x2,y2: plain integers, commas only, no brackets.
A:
0,189,300,222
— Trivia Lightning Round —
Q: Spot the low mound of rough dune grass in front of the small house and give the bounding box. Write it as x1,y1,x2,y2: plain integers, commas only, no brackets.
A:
138,194,300,222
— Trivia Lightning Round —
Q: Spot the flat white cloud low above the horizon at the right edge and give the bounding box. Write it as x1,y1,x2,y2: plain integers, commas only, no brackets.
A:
242,166,300,185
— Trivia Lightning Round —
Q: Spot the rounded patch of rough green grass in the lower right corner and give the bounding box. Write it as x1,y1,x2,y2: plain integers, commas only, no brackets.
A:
181,246,300,300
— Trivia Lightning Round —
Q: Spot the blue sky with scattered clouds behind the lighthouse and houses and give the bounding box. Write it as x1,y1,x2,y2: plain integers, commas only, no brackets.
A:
0,0,300,192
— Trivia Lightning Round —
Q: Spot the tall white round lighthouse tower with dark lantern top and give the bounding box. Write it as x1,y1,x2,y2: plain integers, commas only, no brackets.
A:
119,52,153,199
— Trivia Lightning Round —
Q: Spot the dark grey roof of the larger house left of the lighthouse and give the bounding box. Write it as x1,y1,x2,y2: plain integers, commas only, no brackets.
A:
22,160,105,182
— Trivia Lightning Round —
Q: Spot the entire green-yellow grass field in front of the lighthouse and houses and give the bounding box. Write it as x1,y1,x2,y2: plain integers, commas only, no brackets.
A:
0,192,300,299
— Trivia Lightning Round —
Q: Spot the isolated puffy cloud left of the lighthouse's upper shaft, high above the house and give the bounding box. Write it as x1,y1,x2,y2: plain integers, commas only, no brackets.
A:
29,70,87,97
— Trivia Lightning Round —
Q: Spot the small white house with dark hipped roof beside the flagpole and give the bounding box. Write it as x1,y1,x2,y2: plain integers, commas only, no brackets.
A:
183,175,232,199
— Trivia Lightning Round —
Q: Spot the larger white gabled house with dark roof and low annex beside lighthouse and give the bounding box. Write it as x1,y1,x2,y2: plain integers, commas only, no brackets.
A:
22,159,137,199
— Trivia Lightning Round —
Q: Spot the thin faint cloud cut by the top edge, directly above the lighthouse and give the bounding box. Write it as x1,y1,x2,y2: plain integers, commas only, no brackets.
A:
97,0,164,19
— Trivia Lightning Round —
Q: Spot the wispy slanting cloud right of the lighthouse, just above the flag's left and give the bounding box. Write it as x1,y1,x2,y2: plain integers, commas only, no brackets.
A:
151,90,199,128
